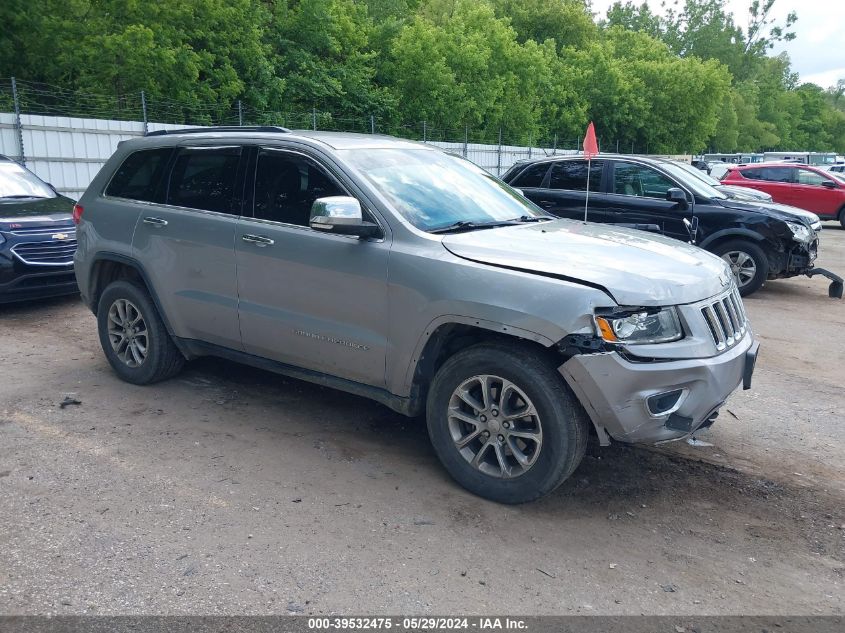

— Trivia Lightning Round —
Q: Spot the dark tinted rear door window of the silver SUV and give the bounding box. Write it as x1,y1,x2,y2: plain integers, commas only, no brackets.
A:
167,147,241,215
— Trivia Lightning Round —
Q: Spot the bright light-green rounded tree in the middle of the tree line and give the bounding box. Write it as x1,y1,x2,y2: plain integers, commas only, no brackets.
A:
386,0,554,138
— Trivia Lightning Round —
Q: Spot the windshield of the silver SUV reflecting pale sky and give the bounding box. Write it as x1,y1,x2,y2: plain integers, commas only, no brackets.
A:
340,149,548,231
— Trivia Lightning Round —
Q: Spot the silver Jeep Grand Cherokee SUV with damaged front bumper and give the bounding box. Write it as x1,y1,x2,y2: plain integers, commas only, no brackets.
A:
75,128,758,503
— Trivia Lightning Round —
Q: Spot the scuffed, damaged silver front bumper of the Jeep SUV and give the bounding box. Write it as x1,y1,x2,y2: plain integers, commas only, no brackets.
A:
558,329,759,444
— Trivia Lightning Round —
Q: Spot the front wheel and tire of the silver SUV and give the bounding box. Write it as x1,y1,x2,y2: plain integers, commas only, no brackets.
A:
426,344,589,503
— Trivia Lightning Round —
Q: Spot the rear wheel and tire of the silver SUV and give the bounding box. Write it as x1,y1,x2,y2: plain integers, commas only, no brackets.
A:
97,280,185,385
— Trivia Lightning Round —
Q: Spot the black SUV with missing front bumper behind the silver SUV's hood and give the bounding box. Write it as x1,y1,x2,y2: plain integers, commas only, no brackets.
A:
503,155,842,296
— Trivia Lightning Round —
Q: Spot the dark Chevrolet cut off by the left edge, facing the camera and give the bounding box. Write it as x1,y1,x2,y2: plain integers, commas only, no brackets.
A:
0,156,77,303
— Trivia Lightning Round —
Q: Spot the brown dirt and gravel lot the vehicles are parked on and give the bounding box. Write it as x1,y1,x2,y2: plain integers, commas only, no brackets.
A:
0,224,845,615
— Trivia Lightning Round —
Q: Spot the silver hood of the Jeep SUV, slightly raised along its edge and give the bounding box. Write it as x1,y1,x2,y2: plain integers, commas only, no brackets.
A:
443,220,731,306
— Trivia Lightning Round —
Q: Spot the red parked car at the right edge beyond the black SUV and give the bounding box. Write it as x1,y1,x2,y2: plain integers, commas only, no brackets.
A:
722,163,845,228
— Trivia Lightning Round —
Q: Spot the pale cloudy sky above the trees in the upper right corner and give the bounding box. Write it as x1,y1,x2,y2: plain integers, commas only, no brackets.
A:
592,0,845,88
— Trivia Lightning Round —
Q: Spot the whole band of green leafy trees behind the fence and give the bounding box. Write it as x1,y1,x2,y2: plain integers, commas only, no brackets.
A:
0,0,845,152
